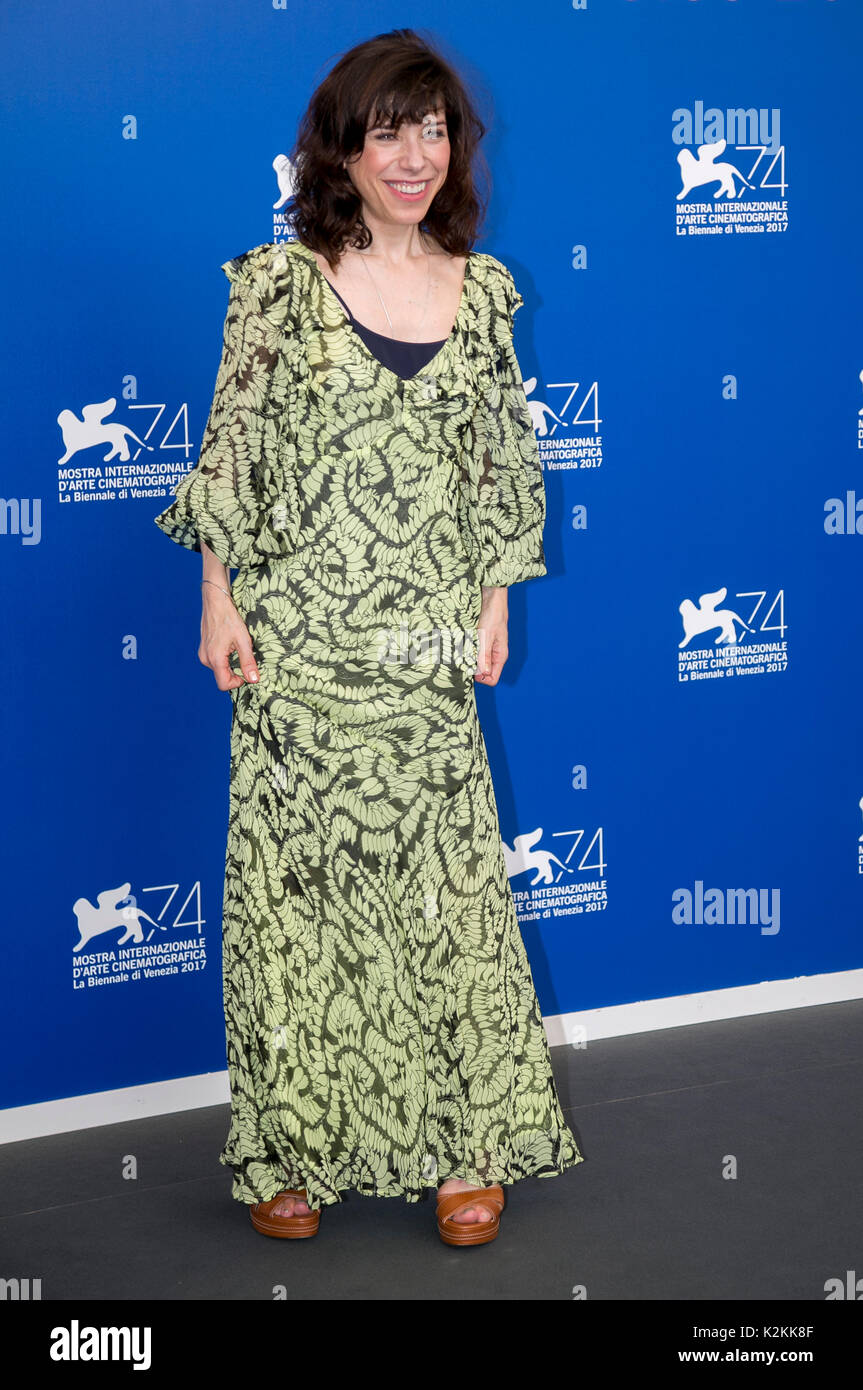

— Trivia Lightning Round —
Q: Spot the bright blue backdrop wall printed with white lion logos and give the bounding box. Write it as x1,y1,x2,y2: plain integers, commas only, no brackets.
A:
0,0,863,1106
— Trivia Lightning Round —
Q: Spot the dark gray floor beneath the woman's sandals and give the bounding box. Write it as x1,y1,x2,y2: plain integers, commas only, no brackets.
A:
0,1002,863,1301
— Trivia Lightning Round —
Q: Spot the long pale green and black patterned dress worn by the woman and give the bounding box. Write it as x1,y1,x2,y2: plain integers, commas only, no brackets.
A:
156,240,582,1209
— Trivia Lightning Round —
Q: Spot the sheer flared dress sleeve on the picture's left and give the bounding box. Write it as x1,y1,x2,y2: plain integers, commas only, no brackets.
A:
154,252,278,569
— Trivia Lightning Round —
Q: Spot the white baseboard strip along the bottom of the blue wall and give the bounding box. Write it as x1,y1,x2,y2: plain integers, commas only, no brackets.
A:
0,970,863,1144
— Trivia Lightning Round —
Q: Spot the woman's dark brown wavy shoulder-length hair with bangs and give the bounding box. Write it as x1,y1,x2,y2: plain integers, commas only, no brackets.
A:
285,29,491,268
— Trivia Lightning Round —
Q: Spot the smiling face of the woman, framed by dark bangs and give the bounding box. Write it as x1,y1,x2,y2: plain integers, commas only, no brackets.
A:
346,106,450,225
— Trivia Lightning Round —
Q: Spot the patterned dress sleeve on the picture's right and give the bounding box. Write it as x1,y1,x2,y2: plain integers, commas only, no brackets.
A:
474,261,548,587
